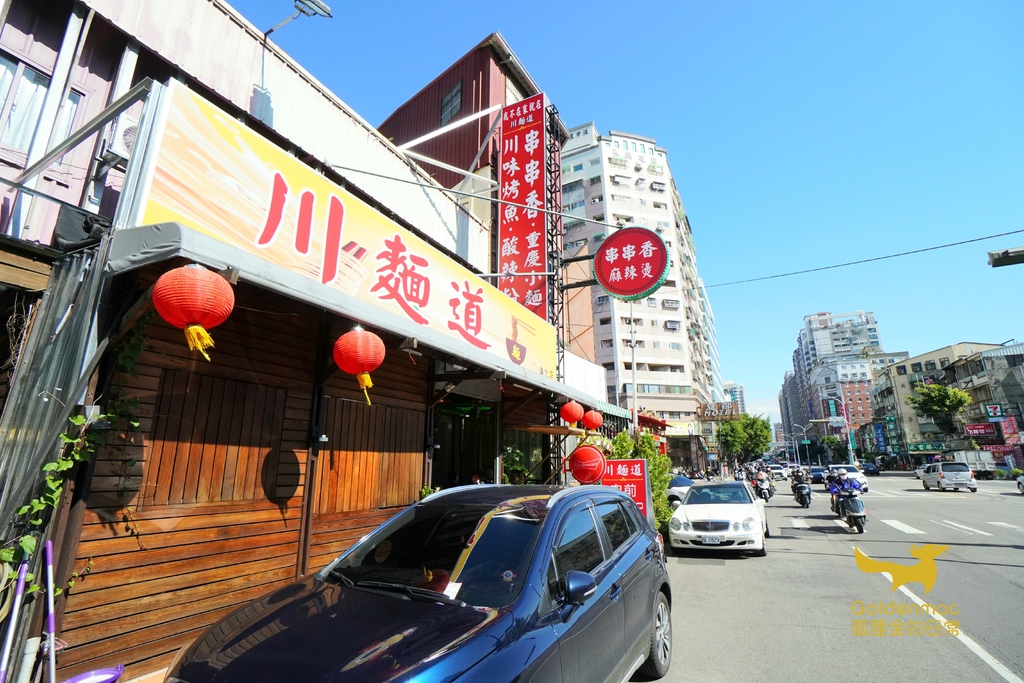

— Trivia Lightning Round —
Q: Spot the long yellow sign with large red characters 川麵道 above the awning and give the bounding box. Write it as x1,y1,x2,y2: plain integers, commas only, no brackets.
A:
141,84,557,378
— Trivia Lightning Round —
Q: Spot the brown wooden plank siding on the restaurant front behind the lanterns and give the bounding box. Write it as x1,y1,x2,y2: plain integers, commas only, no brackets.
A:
58,273,427,680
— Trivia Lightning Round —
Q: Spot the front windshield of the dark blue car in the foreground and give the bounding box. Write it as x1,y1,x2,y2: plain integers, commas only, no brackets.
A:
329,498,547,607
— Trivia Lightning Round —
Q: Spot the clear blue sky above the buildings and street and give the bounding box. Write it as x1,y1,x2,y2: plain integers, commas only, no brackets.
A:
232,0,1024,420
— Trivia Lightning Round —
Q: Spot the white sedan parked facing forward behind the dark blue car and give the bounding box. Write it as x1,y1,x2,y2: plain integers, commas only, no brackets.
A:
669,481,770,557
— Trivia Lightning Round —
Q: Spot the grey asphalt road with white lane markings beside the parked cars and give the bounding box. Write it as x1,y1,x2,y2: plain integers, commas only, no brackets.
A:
633,473,1024,683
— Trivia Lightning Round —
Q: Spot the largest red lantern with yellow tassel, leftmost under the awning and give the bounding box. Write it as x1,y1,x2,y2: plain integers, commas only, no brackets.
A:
153,263,234,360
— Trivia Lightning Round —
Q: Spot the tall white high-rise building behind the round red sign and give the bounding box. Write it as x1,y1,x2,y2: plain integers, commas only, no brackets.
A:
561,123,725,458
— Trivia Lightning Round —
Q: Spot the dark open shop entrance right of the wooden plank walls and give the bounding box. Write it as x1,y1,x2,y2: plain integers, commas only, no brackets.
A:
430,394,498,488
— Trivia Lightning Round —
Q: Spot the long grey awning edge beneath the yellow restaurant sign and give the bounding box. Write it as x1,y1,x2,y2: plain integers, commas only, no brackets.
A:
103,222,610,415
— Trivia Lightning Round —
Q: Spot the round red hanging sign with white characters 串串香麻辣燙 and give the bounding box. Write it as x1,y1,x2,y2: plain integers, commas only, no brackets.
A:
594,227,669,301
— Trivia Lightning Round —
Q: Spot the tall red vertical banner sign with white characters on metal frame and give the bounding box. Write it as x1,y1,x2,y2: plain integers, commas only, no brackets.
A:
498,93,548,322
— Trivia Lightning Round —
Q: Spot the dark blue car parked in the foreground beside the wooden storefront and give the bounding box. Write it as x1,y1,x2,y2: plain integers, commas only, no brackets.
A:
166,485,673,683
